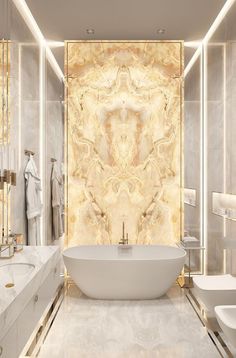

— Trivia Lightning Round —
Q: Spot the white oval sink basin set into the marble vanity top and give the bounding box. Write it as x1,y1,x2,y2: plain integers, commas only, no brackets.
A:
0,262,35,288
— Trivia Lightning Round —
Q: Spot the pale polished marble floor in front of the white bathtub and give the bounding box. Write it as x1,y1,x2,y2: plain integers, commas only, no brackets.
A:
39,283,220,358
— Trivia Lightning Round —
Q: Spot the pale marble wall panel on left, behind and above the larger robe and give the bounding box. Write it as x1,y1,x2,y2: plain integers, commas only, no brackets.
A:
10,4,39,242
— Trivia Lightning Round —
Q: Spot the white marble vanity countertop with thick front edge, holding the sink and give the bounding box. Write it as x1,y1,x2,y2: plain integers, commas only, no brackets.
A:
0,246,60,340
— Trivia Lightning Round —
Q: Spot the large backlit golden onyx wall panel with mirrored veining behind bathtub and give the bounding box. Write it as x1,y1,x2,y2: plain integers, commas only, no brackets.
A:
65,41,182,245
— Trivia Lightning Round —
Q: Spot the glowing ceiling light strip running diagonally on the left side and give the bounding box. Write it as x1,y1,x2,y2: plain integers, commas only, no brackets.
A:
12,0,64,80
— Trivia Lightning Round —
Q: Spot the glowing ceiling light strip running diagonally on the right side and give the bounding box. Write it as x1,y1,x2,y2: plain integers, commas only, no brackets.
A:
184,0,235,77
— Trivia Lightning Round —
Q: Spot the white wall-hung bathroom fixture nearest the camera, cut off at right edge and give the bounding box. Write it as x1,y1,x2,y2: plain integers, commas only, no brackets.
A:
215,305,236,349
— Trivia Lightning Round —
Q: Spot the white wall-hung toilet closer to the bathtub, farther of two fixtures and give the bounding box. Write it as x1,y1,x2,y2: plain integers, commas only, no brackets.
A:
193,274,236,318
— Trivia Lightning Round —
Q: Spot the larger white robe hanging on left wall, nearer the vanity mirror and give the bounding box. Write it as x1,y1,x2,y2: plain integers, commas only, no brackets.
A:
25,155,42,245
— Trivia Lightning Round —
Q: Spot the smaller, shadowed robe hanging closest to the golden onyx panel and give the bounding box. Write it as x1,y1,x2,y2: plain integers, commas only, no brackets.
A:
51,163,63,240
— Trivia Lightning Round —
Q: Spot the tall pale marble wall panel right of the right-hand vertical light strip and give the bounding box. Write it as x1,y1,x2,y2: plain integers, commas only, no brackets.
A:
205,43,224,274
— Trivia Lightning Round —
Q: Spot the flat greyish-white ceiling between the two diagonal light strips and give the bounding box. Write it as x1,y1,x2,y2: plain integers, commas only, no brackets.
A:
23,0,225,68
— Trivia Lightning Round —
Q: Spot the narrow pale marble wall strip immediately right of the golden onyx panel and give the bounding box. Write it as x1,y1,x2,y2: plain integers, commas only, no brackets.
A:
184,57,201,271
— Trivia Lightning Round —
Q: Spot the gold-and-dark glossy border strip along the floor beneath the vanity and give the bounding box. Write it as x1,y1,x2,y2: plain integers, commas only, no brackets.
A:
20,284,65,358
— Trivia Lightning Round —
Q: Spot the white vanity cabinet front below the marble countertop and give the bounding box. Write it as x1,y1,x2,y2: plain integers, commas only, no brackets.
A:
0,261,62,358
